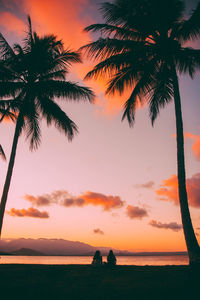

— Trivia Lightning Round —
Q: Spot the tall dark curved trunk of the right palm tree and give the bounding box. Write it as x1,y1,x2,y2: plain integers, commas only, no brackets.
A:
173,66,200,265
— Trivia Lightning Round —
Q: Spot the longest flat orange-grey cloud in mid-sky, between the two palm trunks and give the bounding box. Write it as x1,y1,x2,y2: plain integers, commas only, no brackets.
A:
24,190,124,211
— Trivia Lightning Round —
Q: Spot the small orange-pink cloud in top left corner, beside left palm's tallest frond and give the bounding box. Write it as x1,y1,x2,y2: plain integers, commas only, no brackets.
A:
0,11,25,36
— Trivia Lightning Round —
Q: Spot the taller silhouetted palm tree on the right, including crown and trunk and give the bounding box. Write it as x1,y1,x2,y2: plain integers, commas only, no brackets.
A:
81,0,200,264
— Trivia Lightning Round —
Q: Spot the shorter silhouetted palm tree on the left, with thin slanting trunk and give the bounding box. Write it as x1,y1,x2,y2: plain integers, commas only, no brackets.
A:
0,17,94,234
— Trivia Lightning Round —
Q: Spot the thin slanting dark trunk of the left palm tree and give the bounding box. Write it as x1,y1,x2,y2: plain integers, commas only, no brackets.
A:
0,114,22,237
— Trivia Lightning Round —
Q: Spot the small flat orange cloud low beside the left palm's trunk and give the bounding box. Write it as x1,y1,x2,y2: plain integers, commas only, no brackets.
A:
7,207,49,219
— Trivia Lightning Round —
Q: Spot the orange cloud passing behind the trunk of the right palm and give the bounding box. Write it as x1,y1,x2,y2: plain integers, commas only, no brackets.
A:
155,173,200,207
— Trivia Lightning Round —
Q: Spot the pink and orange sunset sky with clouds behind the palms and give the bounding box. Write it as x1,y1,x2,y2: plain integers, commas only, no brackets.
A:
0,0,200,251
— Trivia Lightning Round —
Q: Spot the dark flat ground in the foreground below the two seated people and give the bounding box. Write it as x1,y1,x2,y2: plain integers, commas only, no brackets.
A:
0,265,200,300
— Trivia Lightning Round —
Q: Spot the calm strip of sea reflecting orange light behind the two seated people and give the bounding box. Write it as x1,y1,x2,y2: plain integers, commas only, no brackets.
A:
0,255,189,266
